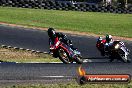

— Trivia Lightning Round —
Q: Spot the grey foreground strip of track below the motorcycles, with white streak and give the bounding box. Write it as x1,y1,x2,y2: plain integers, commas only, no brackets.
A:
0,63,132,84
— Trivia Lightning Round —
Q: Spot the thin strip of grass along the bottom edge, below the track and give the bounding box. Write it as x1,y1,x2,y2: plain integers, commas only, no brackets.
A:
3,83,132,88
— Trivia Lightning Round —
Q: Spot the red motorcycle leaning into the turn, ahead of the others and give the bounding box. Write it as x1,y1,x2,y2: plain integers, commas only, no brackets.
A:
50,39,83,64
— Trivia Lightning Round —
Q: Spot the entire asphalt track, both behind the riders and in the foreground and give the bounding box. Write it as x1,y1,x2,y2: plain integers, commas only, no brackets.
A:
0,25,132,83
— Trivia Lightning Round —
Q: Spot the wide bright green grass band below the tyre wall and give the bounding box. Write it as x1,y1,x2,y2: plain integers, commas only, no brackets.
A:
0,7,132,37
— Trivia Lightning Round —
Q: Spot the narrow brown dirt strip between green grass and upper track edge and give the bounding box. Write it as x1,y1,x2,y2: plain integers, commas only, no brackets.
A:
0,22,132,41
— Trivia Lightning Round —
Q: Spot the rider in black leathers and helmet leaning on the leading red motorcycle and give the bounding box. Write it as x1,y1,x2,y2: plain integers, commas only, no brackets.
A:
47,28,75,50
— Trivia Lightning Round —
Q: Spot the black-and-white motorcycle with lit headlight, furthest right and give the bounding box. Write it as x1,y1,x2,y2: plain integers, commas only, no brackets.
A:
105,41,131,62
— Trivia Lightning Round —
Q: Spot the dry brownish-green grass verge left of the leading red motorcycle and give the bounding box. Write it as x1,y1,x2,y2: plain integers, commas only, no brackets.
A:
0,48,60,63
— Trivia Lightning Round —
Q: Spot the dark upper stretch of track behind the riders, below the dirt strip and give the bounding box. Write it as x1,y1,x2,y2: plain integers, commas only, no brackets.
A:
0,25,132,57
